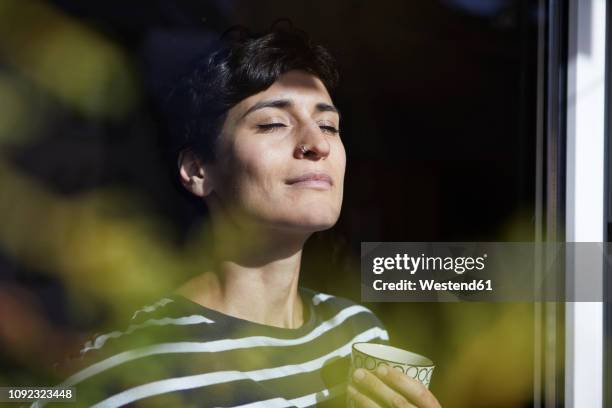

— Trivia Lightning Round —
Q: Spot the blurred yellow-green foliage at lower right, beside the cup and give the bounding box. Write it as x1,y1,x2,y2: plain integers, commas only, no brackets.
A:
366,211,535,407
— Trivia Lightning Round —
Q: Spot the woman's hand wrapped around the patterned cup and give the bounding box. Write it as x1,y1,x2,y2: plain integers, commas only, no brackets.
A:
347,364,440,408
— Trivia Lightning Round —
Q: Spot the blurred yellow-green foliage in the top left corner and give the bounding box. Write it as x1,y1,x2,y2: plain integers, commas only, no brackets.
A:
0,0,139,119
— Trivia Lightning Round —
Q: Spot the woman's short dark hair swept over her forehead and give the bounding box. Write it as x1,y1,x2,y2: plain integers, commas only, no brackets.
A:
164,24,339,161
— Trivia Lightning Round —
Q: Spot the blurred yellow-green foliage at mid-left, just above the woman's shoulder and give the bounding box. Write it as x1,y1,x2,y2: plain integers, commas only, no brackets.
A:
0,159,189,306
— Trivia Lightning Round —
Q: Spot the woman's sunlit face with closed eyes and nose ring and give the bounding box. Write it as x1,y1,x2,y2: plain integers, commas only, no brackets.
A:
209,71,346,232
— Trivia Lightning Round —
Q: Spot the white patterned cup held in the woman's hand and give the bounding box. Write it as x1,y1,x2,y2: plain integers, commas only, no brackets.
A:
349,343,435,388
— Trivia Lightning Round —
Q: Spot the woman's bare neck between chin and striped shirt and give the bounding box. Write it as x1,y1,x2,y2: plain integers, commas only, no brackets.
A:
179,207,308,328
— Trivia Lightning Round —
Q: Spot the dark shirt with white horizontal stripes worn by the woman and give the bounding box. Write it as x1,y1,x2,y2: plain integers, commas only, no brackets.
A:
40,288,389,408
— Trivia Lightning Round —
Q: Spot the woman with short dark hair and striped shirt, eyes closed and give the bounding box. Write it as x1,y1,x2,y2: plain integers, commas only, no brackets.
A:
49,29,439,407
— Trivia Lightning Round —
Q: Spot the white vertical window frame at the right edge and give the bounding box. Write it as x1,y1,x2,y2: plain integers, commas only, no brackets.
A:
565,0,606,408
